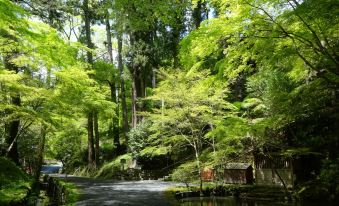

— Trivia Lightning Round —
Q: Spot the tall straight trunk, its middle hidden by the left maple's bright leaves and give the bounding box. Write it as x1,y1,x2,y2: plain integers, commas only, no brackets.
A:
83,0,95,168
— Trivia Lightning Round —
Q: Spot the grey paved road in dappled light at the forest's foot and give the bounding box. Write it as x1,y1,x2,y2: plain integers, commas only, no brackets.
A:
62,177,182,206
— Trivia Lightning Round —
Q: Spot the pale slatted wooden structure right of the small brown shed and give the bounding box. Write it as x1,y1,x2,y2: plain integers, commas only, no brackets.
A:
254,154,295,188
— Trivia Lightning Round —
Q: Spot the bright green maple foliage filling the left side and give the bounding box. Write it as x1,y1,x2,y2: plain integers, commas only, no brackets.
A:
0,0,116,175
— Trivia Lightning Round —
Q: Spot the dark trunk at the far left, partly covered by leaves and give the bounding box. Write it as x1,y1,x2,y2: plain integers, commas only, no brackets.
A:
5,57,21,165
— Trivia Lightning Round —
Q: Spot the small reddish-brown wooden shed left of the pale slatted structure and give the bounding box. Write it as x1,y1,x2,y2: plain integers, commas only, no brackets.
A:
224,163,253,184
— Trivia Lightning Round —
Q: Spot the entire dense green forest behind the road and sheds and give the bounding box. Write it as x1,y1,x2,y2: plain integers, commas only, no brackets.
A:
0,0,339,204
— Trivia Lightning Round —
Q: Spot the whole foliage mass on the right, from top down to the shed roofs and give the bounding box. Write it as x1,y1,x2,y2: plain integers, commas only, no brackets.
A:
175,5,339,200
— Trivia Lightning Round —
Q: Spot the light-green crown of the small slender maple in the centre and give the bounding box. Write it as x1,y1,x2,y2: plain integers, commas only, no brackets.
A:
147,70,228,157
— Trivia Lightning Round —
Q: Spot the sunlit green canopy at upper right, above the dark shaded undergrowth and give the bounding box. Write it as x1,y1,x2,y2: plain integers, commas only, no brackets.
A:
181,0,338,151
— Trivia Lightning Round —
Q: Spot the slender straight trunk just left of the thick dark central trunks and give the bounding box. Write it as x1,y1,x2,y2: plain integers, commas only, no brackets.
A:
118,34,129,146
